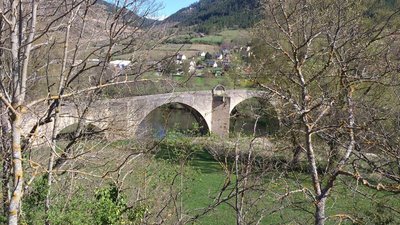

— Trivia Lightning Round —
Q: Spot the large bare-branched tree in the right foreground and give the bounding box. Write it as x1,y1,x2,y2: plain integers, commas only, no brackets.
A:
254,0,400,224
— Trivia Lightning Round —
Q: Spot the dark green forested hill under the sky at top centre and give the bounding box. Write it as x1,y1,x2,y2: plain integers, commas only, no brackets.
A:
166,0,260,33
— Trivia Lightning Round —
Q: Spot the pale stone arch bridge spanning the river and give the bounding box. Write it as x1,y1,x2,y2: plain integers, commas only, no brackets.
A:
24,90,279,143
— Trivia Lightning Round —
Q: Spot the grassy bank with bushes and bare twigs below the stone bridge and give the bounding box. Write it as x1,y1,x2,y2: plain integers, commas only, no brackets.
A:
23,137,400,225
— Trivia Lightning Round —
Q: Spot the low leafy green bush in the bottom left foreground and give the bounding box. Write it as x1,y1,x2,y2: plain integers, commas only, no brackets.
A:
20,180,148,225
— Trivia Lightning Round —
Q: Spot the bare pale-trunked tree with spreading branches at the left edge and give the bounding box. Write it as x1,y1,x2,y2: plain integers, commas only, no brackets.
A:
0,0,166,224
